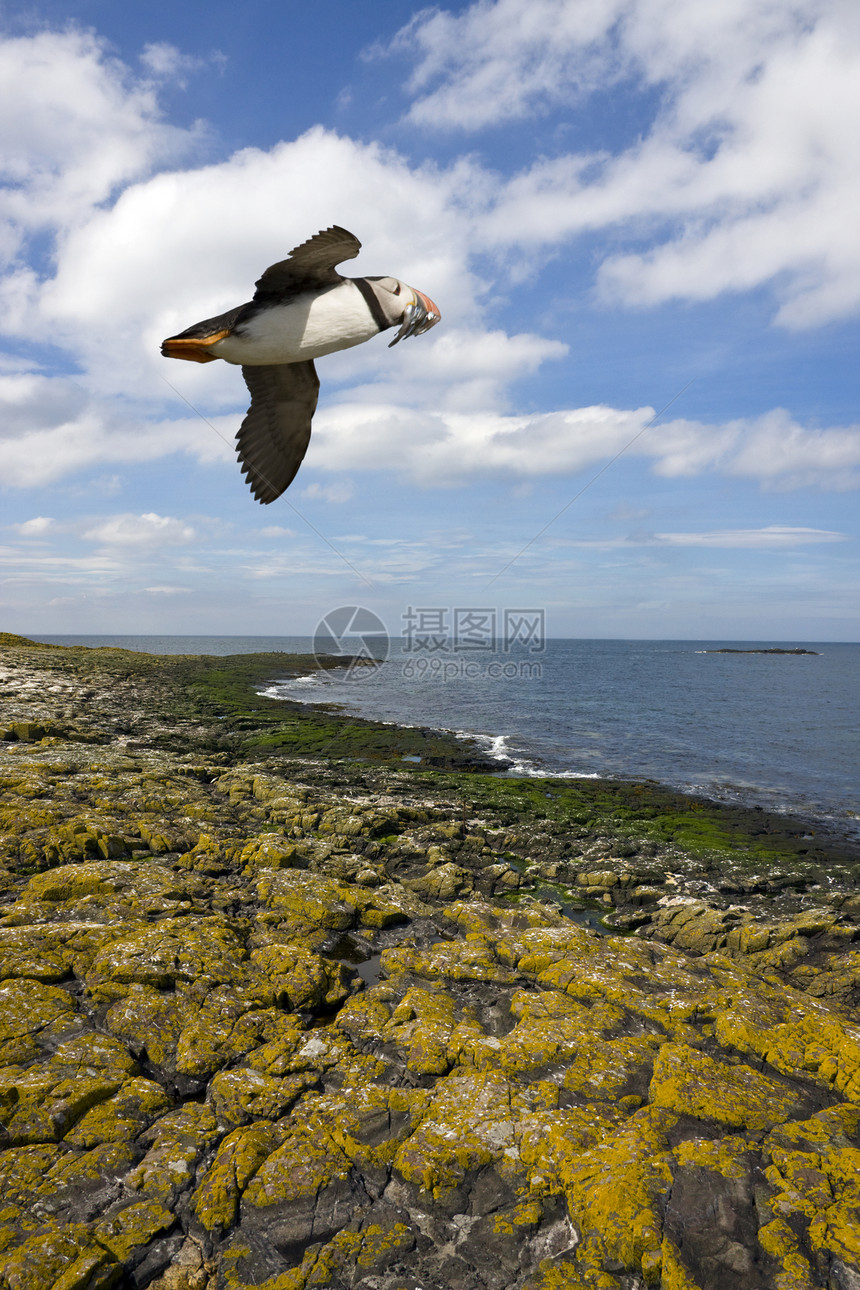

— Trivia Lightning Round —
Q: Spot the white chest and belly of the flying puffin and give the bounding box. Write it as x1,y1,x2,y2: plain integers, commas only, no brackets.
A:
211,283,379,366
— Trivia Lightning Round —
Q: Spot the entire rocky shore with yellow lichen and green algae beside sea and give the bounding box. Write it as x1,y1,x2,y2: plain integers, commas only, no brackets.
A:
0,635,860,1290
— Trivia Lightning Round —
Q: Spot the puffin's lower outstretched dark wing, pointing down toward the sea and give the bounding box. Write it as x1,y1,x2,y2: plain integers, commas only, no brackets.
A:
236,363,320,502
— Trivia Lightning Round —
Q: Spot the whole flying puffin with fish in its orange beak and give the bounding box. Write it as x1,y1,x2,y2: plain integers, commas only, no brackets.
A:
161,224,441,503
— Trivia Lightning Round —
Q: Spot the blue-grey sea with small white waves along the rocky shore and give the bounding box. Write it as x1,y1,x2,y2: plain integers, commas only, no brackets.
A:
30,635,860,837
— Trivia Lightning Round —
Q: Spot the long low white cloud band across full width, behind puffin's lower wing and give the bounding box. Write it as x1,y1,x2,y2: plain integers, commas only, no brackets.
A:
0,333,860,492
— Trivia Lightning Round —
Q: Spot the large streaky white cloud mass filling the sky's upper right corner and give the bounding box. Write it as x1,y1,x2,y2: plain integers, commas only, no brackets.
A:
395,0,860,328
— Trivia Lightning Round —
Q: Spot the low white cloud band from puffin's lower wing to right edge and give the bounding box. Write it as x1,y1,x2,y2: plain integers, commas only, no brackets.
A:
308,402,860,490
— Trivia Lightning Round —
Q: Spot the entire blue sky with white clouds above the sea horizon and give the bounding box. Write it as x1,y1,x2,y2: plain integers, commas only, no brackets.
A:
0,0,860,641
